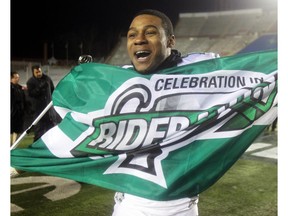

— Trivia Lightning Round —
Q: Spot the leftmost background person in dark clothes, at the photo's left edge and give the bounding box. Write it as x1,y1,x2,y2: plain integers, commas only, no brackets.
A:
10,71,27,145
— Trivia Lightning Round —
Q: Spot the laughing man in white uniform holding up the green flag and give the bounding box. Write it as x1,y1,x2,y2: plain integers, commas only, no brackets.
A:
113,9,219,216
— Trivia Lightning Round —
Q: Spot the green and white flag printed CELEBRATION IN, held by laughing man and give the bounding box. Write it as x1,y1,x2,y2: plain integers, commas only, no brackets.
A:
11,51,277,200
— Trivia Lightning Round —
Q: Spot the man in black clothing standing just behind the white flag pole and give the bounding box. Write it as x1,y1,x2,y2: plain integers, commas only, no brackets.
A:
27,65,61,142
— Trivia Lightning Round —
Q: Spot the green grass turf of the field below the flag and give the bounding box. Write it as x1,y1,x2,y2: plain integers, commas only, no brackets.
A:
11,136,277,216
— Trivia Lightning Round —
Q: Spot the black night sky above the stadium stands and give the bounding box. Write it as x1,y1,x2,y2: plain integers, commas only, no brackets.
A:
10,0,276,59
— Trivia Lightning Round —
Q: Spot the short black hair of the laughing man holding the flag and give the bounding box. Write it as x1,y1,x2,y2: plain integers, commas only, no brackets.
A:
133,9,174,36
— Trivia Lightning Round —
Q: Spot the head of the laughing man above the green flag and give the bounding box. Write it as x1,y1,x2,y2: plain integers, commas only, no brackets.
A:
127,10,177,73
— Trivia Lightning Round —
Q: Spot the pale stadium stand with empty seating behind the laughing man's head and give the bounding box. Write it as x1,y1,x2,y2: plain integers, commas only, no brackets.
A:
106,9,277,66
